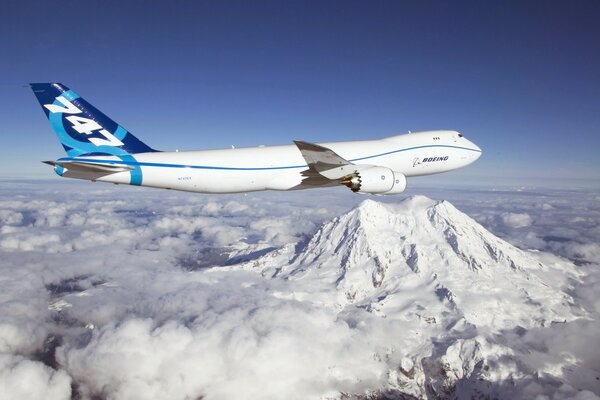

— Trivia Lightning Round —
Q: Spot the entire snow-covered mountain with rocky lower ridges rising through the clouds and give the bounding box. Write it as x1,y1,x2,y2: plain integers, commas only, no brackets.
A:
234,196,580,398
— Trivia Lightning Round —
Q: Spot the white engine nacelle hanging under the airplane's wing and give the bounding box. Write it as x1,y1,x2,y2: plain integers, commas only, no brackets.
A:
341,166,406,194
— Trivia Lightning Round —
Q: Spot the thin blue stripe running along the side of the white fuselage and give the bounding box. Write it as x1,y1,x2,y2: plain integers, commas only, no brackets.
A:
59,144,481,171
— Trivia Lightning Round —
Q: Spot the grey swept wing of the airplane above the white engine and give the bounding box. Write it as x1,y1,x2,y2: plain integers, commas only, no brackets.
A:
294,140,354,180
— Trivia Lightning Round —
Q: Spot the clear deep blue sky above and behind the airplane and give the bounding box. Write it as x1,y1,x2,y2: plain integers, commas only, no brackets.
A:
0,1,600,186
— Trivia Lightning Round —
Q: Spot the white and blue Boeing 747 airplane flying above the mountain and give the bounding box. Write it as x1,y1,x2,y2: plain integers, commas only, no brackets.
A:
30,83,482,195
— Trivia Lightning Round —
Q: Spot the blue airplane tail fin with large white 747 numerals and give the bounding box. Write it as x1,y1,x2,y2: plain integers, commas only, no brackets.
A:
30,83,157,157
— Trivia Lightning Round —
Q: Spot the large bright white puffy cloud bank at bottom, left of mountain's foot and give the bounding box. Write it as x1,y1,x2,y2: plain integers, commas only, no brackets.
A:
58,304,385,399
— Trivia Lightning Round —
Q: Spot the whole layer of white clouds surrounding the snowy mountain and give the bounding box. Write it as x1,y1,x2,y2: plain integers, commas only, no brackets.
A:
0,183,600,399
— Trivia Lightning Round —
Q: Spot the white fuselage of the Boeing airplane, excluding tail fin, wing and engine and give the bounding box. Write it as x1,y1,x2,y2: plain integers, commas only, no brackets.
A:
57,131,481,193
